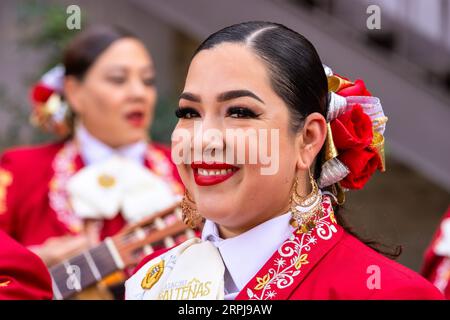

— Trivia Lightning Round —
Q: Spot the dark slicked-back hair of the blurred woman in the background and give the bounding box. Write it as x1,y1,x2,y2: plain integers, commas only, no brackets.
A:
63,26,136,80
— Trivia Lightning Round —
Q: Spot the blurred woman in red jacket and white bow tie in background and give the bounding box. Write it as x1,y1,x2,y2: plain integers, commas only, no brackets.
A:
0,27,183,266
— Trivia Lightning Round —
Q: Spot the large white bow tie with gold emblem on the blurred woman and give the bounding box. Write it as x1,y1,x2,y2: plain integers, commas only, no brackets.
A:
68,156,178,222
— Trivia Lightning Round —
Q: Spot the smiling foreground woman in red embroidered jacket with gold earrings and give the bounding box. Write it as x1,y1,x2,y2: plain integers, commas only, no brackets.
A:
126,22,442,299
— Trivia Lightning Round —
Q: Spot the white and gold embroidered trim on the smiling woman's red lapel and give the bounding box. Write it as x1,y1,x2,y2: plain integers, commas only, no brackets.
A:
247,196,337,300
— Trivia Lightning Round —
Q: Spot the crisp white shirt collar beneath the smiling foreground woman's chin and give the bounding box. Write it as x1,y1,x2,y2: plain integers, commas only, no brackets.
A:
202,212,294,300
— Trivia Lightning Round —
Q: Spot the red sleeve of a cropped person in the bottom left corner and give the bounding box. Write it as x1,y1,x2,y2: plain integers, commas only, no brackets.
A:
0,230,53,300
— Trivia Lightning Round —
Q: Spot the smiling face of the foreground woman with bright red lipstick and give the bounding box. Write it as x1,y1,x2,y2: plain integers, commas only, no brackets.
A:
172,43,325,236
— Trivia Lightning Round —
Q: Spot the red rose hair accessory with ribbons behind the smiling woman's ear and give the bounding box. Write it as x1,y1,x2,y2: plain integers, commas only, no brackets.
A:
319,66,387,199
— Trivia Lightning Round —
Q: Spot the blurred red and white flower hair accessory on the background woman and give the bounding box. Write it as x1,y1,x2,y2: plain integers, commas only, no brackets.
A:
30,65,70,137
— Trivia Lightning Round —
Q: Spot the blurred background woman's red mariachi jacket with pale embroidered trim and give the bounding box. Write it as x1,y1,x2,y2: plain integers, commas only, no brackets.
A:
0,140,183,246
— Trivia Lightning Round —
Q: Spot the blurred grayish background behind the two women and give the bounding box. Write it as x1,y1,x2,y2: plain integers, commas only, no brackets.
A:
0,0,450,271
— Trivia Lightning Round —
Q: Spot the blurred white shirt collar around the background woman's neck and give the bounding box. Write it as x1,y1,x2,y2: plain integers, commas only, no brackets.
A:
75,124,148,166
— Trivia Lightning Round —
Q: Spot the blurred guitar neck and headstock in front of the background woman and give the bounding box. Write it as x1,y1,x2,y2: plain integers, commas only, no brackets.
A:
49,205,195,300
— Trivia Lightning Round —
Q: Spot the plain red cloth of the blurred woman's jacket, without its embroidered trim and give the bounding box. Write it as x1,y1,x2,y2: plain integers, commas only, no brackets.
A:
0,142,181,246
